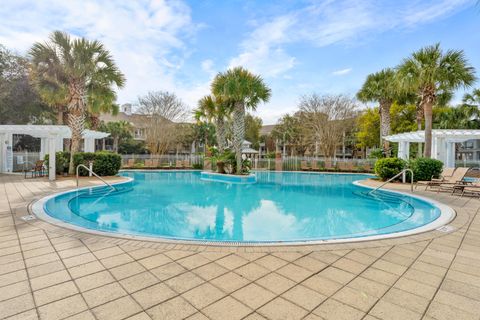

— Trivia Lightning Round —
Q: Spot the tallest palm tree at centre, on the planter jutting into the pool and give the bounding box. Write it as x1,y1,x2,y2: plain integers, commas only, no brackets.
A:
212,67,271,174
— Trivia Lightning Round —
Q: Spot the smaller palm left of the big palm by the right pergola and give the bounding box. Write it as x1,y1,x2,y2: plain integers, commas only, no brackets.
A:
357,68,397,155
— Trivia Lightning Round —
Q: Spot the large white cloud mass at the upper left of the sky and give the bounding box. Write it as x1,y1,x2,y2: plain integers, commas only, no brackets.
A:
0,0,198,107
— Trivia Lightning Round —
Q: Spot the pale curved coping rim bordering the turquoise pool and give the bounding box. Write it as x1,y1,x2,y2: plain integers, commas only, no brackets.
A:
29,170,456,247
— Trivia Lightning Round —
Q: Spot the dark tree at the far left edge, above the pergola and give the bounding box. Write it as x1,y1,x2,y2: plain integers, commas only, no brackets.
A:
0,45,53,124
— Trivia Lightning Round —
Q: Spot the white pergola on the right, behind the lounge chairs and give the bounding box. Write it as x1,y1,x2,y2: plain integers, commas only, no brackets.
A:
384,129,480,167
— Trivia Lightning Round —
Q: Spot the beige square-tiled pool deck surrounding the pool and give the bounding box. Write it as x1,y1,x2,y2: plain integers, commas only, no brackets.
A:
0,175,480,320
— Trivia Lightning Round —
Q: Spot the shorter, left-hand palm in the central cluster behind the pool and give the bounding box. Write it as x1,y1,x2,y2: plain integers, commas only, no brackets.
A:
195,95,232,153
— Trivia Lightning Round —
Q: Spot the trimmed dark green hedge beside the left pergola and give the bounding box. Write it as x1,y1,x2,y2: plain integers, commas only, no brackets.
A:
73,151,122,176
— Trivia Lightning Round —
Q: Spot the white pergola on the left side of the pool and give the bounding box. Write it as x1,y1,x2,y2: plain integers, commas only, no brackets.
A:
0,125,109,180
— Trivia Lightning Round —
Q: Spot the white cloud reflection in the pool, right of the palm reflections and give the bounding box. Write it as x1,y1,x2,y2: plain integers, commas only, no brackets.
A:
243,200,308,240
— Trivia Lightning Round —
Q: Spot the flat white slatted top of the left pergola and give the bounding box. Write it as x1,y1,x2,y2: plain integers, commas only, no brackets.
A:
0,124,110,139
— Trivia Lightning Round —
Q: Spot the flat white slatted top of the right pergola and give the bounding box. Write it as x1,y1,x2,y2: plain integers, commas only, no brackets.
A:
385,129,480,142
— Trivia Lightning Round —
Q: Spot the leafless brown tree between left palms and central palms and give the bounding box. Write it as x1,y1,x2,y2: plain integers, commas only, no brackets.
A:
138,91,189,154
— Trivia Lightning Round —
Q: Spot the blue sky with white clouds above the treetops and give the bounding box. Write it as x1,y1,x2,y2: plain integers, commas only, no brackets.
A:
0,0,480,124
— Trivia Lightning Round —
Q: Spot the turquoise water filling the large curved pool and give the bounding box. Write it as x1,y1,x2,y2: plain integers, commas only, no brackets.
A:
44,171,440,242
